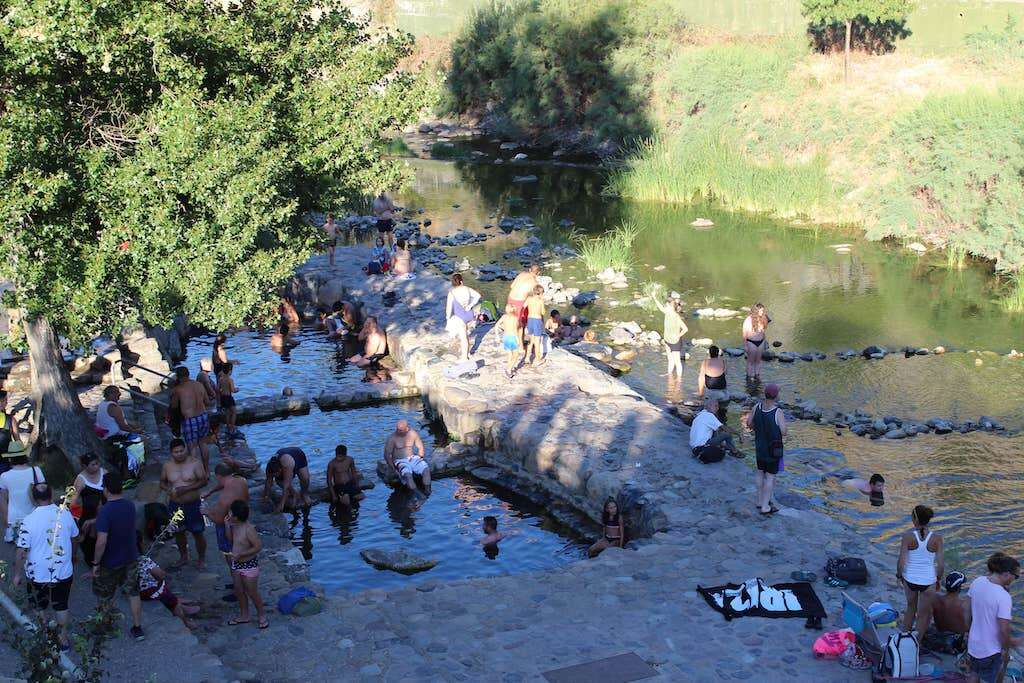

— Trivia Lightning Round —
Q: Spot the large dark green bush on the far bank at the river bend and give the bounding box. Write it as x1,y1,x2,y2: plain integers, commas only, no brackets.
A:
444,0,682,146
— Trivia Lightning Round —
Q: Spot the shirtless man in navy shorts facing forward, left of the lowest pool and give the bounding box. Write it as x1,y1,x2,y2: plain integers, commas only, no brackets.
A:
160,440,207,570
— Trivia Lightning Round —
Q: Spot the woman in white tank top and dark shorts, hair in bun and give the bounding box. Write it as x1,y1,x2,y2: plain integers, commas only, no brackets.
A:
896,505,943,641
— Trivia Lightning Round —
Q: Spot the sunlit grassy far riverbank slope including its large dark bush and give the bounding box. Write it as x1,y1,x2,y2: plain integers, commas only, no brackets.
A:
446,0,1024,271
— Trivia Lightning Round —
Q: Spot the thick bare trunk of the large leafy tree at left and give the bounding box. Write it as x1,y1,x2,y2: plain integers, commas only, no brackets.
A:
24,316,106,472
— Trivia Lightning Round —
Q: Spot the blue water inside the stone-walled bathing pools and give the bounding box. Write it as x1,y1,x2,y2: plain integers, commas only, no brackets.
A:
187,330,587,591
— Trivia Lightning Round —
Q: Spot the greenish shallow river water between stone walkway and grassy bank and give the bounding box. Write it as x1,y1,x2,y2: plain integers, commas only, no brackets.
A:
385,150,1024,602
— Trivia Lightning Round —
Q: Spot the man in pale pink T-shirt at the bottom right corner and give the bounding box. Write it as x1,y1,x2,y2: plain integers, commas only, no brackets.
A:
966,553,1024,683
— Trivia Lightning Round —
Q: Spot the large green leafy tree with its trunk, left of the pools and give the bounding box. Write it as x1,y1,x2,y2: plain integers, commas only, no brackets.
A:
0,0,423,471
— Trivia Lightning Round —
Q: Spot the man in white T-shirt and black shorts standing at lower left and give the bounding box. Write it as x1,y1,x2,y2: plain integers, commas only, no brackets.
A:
13,482,78,650
